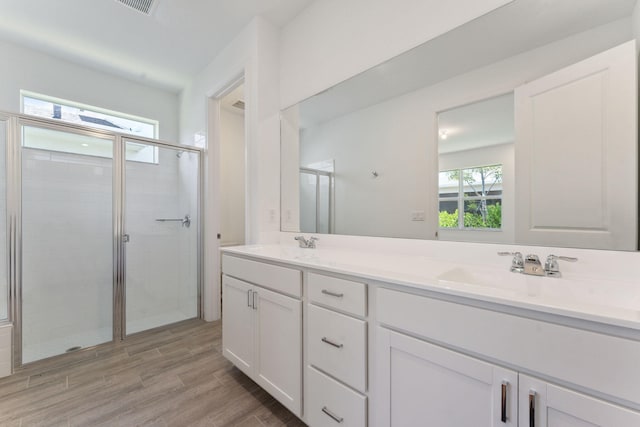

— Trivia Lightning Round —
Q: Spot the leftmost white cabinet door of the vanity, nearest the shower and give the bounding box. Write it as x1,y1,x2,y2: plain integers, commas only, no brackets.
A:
222,275,254,376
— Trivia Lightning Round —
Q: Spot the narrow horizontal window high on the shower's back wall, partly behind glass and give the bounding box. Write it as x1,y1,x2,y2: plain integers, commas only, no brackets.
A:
20,91,158,164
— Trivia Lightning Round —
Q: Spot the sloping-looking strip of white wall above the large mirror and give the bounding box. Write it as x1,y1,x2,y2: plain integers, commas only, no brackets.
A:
280,0,511,108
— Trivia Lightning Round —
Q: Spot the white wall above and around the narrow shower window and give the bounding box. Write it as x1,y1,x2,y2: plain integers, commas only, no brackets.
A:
0,37,178,141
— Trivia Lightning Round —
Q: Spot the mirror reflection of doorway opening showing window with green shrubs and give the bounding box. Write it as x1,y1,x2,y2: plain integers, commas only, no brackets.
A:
438,93,515,242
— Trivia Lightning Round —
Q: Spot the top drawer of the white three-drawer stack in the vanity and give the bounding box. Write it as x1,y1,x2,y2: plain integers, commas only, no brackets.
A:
307,273,367,317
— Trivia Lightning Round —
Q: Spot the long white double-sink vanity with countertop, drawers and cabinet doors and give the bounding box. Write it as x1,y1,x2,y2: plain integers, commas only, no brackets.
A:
222,245,640,427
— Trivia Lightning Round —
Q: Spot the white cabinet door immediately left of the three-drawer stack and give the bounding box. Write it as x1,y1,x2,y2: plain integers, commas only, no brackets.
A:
255,287,302,415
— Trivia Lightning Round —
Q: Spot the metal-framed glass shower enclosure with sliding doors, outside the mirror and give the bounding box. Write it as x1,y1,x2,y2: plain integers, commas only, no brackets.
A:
0,115,202,366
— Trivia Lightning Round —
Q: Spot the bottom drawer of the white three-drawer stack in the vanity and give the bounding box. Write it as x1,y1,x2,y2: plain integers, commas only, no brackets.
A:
305,366,367,427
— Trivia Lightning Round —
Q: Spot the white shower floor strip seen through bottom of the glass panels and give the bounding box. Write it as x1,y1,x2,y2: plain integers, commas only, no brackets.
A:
22,311,196,364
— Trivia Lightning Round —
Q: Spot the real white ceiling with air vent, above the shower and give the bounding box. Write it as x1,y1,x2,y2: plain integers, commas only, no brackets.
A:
0,0,312,92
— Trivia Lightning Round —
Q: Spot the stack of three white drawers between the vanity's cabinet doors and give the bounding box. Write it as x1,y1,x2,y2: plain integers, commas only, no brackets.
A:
305,272,367,427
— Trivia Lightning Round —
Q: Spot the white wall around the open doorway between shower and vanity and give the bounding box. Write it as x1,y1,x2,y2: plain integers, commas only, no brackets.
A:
180,17,280,320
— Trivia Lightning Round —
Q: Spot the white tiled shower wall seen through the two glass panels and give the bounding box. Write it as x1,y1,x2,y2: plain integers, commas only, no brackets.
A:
20,143,198,364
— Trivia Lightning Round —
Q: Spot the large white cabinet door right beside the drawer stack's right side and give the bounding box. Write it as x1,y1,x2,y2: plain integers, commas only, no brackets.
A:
376,327,518,427
